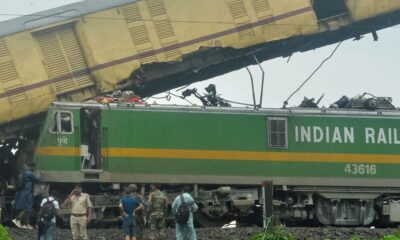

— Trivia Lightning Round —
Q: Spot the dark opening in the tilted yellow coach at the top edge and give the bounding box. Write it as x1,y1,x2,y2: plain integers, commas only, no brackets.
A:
313,0,348,21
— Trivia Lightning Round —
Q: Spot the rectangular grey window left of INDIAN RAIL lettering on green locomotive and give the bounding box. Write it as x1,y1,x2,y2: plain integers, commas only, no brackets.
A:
268,117,287,148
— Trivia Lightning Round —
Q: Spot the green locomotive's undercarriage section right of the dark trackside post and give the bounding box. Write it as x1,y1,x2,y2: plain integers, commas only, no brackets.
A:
273,187,400,226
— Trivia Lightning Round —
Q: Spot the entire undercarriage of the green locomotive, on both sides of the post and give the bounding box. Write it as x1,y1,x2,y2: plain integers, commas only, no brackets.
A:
28,183,400,227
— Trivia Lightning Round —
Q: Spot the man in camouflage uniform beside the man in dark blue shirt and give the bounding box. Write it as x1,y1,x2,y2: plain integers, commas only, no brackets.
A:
147,184,167,239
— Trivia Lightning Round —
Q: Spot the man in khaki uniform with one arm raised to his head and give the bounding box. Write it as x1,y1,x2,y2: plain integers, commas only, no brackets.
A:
62,184,92,240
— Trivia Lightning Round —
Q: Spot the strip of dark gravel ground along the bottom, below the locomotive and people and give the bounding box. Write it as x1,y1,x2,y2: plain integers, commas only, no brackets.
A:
8,227,398,240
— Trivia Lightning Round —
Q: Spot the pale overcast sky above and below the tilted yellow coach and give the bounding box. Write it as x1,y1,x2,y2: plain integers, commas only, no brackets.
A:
0,0,400,107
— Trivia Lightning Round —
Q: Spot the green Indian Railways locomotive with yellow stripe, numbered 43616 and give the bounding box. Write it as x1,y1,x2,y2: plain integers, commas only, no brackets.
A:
34,103,400,226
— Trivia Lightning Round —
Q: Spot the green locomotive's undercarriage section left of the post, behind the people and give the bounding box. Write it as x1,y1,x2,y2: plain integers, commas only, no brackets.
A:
34,183,261,227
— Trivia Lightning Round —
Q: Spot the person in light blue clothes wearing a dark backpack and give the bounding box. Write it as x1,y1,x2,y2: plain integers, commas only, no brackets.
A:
172,186,198,240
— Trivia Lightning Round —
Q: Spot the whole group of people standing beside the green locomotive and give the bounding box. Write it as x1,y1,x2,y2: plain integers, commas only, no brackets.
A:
7,167,198,240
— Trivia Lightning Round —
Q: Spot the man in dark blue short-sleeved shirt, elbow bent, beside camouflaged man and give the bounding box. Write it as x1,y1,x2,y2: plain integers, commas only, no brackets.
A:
119,188,144,240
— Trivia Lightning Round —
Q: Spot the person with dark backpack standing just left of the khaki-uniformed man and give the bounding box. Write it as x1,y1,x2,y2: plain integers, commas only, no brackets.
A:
38,193,60,240
